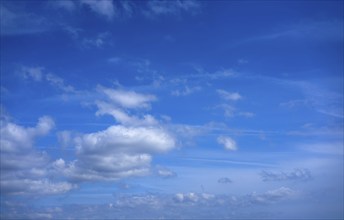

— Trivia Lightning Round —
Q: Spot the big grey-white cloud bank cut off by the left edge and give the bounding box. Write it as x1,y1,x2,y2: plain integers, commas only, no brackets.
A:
0,116,75,194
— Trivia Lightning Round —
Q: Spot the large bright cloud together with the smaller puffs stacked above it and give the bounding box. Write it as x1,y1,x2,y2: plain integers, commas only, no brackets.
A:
53,86,176,181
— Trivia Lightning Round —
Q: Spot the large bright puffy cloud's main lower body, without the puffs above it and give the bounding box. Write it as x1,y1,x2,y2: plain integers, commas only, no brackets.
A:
54,125,175,181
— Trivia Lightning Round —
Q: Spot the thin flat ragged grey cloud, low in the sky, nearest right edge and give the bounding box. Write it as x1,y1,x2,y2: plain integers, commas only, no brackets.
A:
260,168,312,181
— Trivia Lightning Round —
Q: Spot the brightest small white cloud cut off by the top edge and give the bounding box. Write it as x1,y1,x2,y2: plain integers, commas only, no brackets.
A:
81,0,117,20
